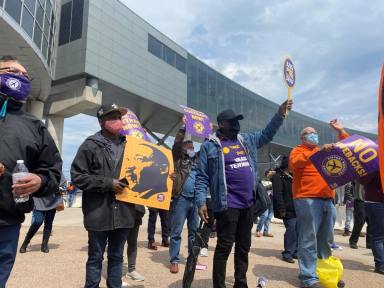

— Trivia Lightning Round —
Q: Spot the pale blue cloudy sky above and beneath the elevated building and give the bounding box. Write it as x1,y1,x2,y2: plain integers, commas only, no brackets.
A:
64,0,384,177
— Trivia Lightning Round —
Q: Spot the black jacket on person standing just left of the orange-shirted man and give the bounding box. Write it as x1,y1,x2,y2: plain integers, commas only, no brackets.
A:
272,169,296,219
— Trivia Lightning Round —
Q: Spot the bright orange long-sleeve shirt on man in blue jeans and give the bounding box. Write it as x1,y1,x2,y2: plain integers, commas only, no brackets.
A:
289,133,349,199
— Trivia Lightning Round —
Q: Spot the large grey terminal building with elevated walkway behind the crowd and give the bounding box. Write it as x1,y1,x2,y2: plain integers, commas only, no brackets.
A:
0,0,376,173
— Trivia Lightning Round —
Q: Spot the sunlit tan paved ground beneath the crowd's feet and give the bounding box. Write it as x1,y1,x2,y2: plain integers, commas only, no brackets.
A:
7,208,384,288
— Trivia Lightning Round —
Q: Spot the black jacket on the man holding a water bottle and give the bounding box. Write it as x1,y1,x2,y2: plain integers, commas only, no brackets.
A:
0,100,62,226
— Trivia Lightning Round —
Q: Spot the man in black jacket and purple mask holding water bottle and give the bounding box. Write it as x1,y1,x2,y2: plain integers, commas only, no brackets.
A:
0,56,62,288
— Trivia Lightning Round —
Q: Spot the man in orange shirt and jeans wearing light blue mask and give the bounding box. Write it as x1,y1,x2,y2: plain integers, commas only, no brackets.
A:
289,119,349,288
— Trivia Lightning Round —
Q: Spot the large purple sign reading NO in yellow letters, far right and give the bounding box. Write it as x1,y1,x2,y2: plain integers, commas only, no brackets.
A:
310,135,379,189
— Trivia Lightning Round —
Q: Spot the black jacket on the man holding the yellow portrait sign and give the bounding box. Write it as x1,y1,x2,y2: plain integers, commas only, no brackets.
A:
71,132,136,231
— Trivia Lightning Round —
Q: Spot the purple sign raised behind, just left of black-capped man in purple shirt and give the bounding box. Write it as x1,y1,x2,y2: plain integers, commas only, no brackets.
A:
180,105,212,138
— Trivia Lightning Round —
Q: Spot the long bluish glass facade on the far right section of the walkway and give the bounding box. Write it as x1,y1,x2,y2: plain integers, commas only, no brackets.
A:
187,55,344,150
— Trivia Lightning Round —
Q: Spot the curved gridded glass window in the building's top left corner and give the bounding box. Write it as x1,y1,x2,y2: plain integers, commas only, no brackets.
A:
0,0,56,67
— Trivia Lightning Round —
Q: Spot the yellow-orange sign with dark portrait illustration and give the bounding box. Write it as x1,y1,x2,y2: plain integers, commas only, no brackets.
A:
116,136,173,210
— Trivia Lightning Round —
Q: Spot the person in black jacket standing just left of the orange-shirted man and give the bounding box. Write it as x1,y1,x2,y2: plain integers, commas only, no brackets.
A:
272,156,297,263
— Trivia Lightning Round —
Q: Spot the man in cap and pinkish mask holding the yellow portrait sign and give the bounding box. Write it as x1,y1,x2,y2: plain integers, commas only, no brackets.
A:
71,104,135,288
